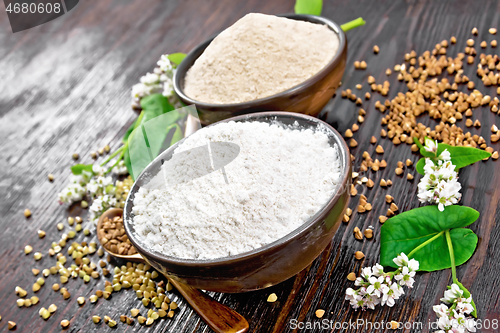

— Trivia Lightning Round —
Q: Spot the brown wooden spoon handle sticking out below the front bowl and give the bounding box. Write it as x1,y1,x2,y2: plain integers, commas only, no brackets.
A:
168,279,249,333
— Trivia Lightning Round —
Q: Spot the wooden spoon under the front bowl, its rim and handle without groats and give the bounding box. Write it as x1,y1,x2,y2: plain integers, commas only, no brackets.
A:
97,208,249,333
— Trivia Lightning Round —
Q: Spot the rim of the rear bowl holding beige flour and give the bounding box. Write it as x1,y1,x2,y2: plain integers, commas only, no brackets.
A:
172,13,347,107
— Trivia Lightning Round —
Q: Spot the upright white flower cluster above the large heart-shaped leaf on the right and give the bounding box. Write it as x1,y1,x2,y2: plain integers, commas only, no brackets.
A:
418,140,462,211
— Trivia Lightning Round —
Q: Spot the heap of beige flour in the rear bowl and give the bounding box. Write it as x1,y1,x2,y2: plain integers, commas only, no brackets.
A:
184,14,339,104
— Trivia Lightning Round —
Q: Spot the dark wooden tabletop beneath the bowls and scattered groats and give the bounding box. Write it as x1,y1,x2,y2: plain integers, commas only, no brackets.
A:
0,0,500,332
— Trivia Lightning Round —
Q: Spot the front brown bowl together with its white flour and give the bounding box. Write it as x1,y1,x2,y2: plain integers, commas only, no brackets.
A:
124,112,351,292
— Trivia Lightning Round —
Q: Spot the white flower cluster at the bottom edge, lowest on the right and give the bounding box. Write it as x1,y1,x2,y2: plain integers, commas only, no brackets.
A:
433,283,476,333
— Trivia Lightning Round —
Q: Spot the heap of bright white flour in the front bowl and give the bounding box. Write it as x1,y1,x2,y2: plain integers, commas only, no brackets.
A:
133,122,342,259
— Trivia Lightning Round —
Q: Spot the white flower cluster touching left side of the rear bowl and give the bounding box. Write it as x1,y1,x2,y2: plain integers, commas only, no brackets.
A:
132,54,182,110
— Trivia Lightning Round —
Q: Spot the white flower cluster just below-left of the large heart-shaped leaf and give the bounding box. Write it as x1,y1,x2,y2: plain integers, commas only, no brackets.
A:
345,253,419,309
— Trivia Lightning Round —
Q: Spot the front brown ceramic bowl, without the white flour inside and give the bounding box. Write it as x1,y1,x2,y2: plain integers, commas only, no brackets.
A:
124,112,351,293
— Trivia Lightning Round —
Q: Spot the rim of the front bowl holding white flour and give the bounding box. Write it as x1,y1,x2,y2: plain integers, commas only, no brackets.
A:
123,111,351,268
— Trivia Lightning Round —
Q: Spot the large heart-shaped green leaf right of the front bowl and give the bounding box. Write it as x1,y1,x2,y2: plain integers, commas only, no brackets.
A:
380,205,479,272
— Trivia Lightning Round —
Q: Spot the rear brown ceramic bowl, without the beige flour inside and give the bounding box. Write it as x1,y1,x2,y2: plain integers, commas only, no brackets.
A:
173,14,347,125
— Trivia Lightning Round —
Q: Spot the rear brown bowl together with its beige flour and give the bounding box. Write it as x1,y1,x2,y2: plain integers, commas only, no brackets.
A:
173,14,347,124
